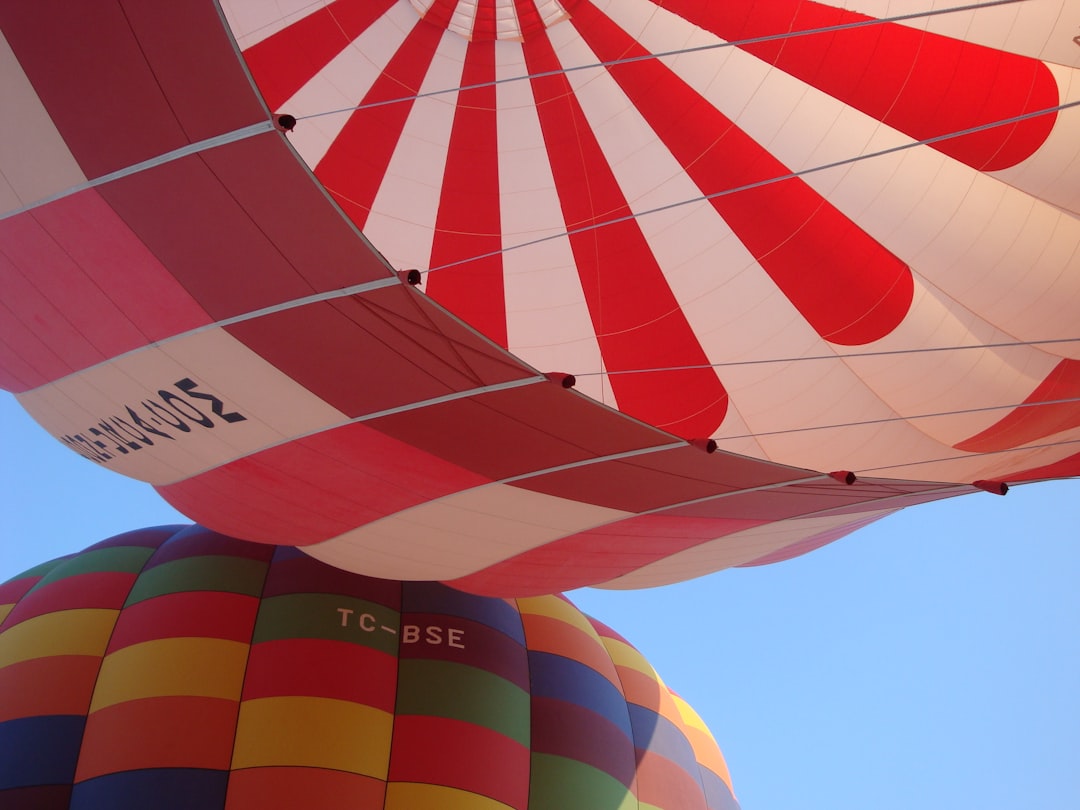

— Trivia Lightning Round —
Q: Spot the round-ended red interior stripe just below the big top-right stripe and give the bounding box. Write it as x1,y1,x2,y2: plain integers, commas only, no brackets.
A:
575,3,915,347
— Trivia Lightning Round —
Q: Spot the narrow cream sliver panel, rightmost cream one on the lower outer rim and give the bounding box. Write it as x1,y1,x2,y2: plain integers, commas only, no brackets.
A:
594,509,895,591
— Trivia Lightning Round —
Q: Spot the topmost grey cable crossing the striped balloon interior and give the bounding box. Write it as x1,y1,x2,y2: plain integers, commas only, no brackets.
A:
294,0,1030,121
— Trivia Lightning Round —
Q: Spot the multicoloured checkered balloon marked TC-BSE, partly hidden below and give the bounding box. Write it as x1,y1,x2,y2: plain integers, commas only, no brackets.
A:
0,526,738,810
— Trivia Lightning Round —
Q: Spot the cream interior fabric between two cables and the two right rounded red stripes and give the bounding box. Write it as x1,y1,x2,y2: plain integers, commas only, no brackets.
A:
809,147,1080,357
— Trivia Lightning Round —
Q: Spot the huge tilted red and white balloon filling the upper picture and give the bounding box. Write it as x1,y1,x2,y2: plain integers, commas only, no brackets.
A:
0,0,1080,596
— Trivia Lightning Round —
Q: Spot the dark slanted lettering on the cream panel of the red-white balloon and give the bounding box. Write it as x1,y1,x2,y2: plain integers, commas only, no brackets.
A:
60,377,247,464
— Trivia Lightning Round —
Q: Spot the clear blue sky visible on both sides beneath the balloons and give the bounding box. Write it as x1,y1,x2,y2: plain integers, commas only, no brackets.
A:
0,394,1080,810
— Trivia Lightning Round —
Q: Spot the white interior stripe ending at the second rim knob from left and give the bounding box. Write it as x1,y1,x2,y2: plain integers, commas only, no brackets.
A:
364,26,467,270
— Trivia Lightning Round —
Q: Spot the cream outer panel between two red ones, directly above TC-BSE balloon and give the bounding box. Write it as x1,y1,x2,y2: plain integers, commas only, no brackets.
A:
303,484,630,580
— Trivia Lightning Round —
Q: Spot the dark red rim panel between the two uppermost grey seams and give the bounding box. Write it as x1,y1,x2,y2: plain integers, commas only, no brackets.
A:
99,141,389,320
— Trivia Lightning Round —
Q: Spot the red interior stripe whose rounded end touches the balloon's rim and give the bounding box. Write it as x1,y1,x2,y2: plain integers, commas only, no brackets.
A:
524,31,727,437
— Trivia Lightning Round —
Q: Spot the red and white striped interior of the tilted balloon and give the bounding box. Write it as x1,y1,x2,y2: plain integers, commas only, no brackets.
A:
222,0,1080,483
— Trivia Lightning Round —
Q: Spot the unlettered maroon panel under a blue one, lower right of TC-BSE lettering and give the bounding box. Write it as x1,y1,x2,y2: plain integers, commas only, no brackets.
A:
531,696,635,786
